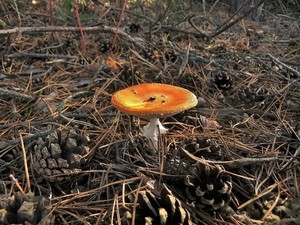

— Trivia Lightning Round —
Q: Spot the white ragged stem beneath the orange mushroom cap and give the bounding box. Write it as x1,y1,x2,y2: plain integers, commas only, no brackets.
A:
142,118,168,149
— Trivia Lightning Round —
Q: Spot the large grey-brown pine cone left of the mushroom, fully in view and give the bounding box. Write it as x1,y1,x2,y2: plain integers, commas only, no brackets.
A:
33,129,89,182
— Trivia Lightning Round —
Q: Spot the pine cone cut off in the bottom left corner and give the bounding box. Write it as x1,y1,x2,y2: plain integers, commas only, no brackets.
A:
0,192,54,225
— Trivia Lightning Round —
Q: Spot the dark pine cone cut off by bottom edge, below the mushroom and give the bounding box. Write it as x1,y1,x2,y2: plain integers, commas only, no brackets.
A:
125,186,193,225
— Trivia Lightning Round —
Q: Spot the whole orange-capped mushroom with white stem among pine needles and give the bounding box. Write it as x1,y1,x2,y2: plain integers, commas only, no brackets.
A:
111,83,198,149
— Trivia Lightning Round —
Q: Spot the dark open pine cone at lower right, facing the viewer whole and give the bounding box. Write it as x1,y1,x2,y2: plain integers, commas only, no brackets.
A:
184,164,232,210
